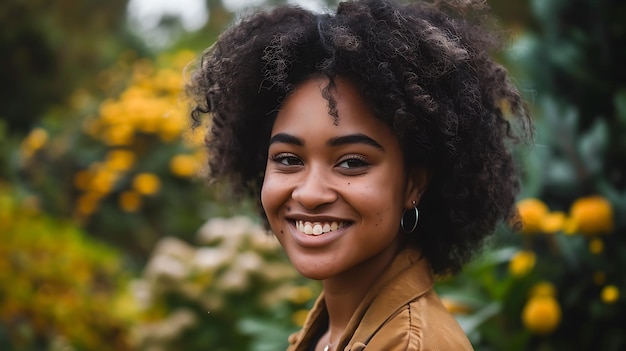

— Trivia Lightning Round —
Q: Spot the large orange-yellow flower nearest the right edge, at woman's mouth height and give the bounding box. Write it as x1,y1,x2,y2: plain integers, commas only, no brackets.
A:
570,196,613,235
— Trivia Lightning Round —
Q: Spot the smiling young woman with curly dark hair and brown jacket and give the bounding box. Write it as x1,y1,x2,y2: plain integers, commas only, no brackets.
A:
188,0,530,351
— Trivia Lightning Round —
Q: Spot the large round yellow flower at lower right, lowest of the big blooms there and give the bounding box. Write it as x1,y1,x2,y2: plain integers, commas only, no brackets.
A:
522,295,561,334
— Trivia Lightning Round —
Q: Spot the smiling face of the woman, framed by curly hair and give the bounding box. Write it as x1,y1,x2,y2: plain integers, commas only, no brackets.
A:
261,79,424,280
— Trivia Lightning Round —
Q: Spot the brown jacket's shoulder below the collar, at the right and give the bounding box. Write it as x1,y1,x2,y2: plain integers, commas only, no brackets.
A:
354,290,473,351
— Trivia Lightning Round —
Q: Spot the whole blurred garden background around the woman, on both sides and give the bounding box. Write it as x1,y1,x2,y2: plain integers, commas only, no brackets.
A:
0,0,626,351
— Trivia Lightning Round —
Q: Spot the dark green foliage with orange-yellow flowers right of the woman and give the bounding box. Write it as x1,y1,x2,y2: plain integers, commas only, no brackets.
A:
440,0,626,350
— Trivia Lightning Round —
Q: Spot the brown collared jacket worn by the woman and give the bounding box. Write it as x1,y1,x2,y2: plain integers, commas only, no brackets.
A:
287,249,473,351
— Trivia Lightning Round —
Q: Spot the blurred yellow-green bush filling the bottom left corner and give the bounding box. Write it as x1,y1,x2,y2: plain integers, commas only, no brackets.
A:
0,184,132,351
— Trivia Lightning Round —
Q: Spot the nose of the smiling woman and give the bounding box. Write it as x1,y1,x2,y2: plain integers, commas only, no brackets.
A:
291,167,337,210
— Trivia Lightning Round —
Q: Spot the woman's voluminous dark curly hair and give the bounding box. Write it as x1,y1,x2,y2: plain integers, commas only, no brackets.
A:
187,0,532,274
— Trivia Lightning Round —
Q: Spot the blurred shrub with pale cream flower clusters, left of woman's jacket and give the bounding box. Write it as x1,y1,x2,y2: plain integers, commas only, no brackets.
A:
133,217,319,351
